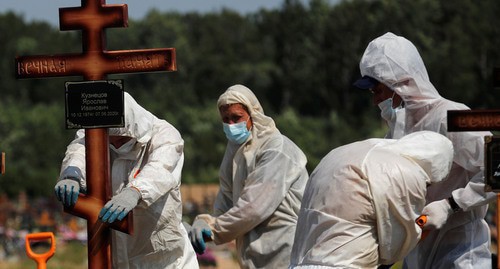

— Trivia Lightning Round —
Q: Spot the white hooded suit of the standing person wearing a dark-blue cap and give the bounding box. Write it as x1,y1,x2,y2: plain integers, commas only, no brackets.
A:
360,33,496,269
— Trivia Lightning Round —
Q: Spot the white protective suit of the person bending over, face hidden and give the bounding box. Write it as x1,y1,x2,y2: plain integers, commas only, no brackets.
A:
290,131,453,269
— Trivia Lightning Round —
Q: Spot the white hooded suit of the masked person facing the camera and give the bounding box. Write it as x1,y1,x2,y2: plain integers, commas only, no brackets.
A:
198,85,309,268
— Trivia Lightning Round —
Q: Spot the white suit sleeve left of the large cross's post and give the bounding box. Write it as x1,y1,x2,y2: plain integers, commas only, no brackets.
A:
59,129,87,189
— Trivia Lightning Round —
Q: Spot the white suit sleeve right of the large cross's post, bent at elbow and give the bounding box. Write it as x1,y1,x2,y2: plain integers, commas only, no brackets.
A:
127,120,184,207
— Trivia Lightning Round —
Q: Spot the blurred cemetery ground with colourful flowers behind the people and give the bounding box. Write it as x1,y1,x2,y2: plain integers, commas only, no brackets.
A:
0,184,237,269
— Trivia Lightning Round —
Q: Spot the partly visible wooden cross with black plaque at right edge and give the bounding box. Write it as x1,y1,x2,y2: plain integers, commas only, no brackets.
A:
447,68,500,268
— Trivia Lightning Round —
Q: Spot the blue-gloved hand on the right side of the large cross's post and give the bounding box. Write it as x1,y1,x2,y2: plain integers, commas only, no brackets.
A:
99,185,141,223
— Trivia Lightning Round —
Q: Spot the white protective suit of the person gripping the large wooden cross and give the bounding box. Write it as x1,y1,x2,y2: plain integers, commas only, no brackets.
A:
61,92,198,269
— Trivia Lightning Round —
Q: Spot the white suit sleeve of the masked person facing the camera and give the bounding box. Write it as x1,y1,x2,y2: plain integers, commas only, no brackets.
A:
209,149,302,244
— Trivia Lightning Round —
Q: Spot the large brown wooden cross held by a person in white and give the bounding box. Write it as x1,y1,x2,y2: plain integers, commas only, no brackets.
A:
16,0,176,268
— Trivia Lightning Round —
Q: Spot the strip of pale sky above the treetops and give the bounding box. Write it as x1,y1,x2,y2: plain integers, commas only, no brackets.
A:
0,0,290,26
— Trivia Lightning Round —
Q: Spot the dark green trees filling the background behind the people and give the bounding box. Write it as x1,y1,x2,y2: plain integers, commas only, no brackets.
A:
0,0,500,196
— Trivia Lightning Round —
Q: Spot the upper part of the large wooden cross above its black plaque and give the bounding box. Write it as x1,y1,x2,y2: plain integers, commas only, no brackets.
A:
16,0,177,80
